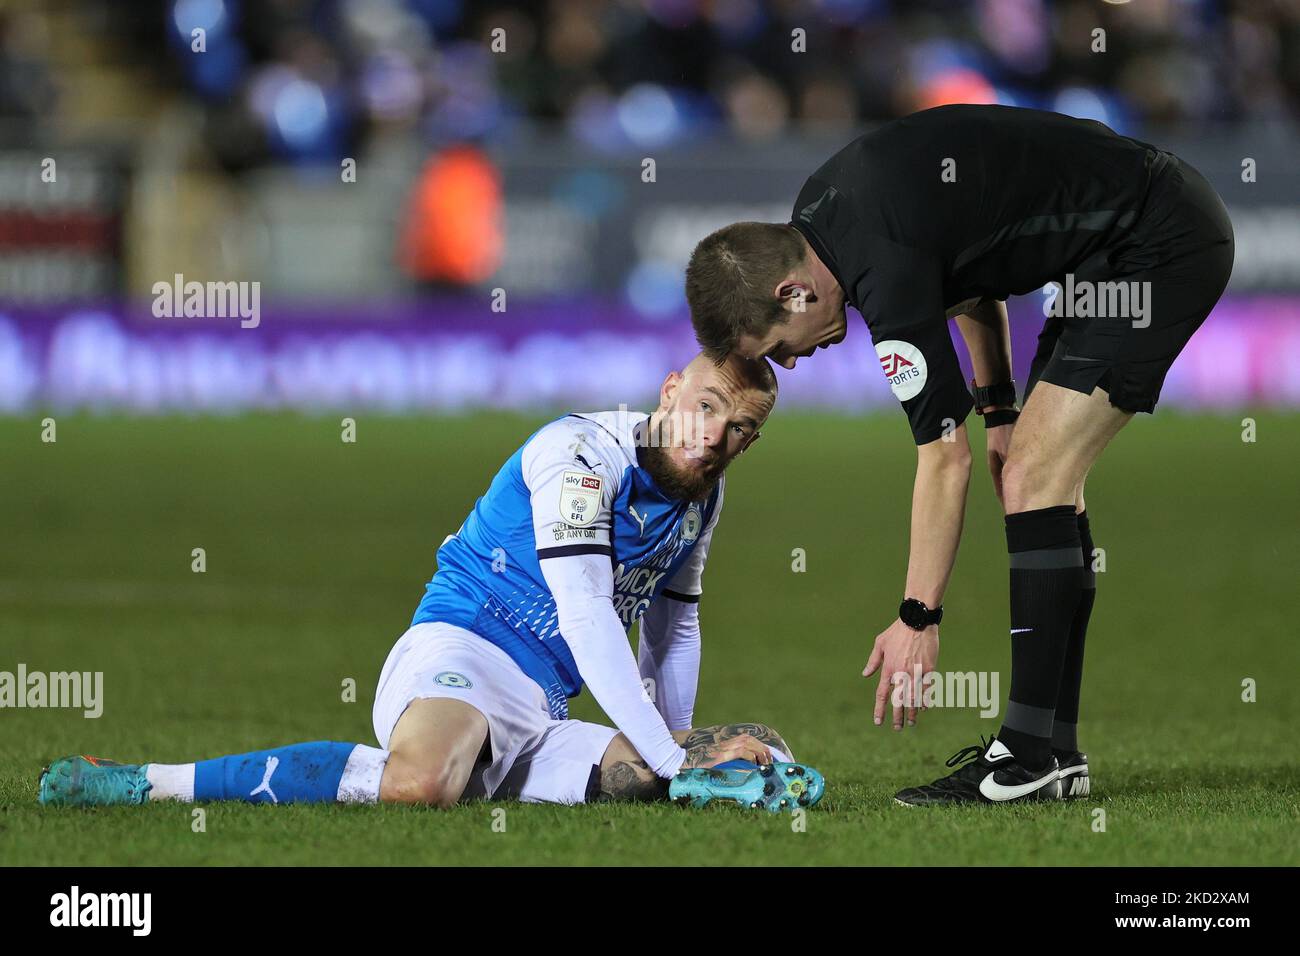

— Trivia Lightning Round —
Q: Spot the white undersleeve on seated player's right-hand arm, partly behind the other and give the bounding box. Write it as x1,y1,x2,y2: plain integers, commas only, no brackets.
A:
637,594,701,730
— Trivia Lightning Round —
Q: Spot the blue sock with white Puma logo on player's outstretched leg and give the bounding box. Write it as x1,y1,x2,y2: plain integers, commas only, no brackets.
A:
194,740,358,804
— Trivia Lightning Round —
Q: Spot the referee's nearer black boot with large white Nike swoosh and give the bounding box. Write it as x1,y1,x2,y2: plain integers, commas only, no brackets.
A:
894,737,1061,806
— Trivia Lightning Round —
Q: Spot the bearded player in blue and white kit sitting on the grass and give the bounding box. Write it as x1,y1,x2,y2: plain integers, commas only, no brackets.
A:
48,356,824,810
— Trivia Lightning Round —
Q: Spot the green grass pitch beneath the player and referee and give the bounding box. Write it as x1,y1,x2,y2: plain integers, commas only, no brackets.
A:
0,412,1300,865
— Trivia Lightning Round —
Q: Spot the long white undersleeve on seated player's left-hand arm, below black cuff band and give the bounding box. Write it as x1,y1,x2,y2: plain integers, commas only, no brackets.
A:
541,554,686,778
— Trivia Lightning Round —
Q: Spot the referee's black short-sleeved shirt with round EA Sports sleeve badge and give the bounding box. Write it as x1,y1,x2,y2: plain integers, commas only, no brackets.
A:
792,105,1167,445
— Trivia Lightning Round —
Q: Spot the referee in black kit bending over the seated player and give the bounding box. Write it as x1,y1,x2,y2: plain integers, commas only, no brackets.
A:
686,105,1232,805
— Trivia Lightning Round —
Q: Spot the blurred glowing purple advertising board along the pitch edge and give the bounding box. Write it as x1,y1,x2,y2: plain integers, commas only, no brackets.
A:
0,297,1300,414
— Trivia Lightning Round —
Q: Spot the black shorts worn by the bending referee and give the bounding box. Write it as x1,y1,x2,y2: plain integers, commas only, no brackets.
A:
1024,153,1234,412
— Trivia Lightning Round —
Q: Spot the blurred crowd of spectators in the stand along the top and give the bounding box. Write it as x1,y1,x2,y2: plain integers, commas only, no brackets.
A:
0,0,1300,169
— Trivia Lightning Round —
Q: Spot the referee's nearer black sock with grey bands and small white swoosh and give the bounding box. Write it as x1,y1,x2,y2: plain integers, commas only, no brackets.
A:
997,505,1083,770
